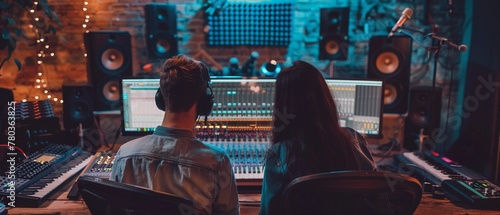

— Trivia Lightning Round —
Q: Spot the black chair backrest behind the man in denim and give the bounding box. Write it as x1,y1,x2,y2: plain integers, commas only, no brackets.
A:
77,176,207,215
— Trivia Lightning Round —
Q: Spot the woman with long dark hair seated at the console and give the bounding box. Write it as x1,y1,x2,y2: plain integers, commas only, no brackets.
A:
260,61,376,214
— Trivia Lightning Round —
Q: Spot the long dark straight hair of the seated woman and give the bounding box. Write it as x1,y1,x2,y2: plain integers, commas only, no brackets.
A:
272,60,359,172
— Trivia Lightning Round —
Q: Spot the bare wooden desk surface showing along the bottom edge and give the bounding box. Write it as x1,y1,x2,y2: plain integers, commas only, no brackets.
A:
8,186,500,215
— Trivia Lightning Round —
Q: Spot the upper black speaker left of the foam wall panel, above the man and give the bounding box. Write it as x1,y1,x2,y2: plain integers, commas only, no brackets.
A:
144,3,178,59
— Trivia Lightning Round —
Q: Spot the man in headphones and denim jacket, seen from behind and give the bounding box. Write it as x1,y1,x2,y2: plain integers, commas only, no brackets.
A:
111,55,239,214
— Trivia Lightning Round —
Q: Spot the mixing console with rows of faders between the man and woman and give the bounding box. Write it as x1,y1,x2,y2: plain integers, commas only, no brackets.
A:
195,117,271,187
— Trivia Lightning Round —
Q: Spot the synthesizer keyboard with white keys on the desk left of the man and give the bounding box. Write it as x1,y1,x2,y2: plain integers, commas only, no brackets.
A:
0,144,92,207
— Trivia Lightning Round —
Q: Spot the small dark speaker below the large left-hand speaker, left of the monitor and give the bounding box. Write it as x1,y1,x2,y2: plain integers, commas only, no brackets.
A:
62,83,94,130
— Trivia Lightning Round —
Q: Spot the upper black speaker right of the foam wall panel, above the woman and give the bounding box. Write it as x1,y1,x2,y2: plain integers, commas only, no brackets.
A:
319,7,349,60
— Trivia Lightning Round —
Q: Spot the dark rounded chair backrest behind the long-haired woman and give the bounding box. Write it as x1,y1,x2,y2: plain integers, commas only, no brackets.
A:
283,171,422,215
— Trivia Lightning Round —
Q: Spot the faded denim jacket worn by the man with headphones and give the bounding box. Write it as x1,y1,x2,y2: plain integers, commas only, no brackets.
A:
110,126,239,214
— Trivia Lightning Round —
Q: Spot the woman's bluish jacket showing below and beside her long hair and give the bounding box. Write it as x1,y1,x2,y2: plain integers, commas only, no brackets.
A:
260,128,376,215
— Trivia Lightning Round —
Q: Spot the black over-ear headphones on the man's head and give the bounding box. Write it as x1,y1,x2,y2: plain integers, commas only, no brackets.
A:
155,63,214,116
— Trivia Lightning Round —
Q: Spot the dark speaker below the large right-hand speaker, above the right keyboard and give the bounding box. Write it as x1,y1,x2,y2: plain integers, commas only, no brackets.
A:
404,86,442,151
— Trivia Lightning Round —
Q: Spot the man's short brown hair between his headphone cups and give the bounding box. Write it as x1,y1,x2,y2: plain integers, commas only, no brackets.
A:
160,55,208,112
